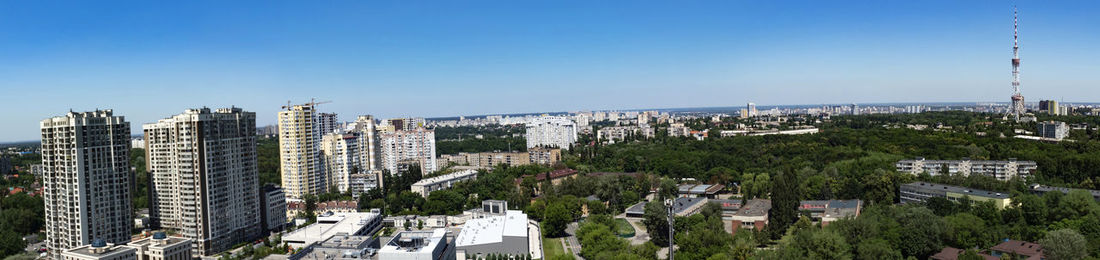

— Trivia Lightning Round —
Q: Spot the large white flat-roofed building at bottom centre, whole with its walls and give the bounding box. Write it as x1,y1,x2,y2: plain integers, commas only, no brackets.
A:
455,210,530,258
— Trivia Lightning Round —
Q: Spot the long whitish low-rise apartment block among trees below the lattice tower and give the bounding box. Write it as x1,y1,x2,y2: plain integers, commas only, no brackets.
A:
895,158,1038,181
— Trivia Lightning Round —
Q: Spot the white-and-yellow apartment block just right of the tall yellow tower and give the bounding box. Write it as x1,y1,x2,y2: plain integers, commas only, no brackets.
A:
321,133,362,193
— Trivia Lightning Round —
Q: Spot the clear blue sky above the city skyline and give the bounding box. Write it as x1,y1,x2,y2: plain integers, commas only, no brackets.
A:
0,0,1100,142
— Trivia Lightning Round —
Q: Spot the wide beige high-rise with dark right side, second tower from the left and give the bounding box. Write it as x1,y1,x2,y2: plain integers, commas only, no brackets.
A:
142,108,261,256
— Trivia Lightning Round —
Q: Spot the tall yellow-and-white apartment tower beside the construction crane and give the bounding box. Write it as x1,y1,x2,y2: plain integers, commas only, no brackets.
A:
278,104,327,199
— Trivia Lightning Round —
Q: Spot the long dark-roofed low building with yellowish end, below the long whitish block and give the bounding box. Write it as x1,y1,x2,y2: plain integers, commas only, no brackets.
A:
899,182,1012,209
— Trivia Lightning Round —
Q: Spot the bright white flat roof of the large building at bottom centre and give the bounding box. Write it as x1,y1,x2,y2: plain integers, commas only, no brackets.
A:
455,210,528,247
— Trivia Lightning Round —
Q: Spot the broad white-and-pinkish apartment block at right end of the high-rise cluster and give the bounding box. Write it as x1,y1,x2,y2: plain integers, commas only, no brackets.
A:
380,128,437,174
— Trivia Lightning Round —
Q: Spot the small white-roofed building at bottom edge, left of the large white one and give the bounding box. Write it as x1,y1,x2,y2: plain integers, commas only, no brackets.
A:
378,228,454,260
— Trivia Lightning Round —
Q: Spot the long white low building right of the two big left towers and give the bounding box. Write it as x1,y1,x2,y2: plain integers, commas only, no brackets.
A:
283,209,382,249
